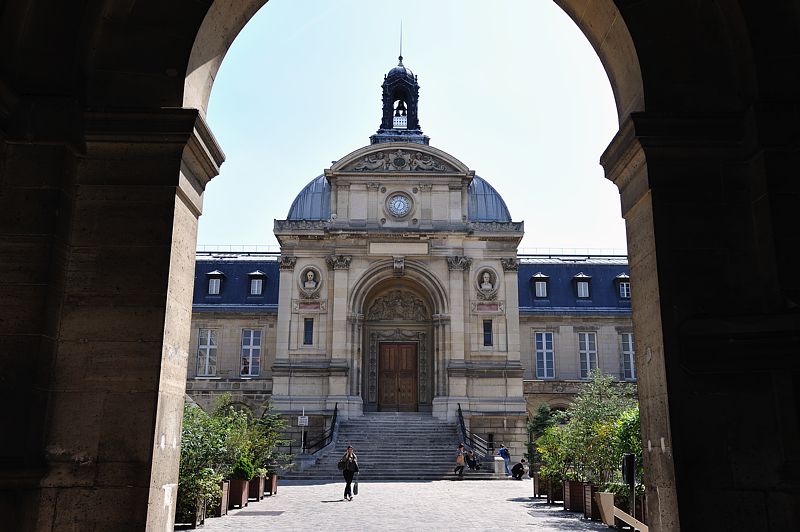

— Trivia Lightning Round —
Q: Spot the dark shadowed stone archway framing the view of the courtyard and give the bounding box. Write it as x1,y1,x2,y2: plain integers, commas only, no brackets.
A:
6,0,800,530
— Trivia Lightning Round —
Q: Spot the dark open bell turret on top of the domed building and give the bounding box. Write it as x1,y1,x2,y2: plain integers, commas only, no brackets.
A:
370,55,430,144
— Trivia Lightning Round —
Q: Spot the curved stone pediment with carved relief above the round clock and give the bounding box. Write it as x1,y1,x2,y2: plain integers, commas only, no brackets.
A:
331,142,469,173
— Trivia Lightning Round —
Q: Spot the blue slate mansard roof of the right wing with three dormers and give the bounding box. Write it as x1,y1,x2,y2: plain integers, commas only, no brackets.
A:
518,255,631,315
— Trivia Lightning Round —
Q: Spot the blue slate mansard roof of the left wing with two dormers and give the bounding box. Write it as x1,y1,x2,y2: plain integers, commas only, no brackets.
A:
192,252,280,313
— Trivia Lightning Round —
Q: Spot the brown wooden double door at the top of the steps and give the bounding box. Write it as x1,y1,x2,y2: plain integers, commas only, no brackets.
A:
378,343,418,412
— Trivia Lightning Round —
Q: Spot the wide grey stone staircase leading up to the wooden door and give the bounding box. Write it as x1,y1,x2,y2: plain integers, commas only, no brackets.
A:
282,412,493,480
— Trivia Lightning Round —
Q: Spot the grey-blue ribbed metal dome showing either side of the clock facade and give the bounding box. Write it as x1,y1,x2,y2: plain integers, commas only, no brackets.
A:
286,175,511,222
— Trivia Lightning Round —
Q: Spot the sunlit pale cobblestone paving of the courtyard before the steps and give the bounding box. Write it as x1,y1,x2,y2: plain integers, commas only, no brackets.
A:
197,480,608,532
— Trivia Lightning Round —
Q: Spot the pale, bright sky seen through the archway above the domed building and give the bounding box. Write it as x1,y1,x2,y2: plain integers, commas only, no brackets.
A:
198,0,626,253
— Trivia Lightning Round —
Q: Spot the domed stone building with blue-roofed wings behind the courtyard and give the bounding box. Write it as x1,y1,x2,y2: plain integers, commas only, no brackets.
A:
188,58,634,453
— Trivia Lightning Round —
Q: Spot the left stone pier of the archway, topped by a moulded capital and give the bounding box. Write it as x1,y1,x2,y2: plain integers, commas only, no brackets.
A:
0,109,223,530
